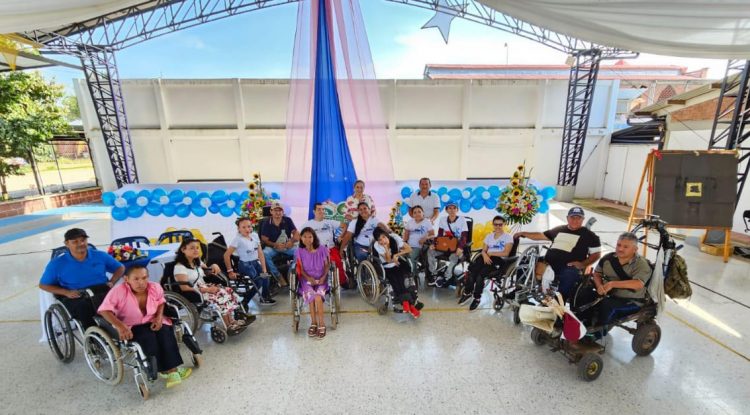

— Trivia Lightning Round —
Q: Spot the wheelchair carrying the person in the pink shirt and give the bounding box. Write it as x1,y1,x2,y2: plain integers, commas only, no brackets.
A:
83,304,203,400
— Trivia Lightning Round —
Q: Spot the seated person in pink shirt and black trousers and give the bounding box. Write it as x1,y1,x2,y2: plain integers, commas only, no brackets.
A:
98,265,192,388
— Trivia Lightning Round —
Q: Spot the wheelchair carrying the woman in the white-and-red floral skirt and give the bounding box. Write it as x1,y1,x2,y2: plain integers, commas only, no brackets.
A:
160,262,249,344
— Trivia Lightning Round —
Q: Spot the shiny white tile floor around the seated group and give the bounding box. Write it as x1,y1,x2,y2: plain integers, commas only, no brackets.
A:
0,205,750,414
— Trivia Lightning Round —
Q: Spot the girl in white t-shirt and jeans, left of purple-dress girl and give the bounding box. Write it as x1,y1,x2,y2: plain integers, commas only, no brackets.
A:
223,218,276,307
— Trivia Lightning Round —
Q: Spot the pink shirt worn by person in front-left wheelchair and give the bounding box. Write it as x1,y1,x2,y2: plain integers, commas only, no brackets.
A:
98,281,172,328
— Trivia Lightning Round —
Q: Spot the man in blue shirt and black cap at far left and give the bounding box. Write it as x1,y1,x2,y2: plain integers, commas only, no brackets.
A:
39,228,125,330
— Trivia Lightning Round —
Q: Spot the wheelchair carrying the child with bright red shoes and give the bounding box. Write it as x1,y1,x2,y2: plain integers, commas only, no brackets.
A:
352,242,424,315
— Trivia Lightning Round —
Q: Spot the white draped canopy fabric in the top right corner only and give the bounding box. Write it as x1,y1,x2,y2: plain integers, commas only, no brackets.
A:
478,0,750,59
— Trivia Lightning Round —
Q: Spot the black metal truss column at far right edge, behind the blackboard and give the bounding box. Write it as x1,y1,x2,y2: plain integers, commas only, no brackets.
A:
708,60,750,209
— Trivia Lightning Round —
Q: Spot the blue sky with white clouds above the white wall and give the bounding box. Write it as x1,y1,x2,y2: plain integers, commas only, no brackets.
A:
43,0,726,94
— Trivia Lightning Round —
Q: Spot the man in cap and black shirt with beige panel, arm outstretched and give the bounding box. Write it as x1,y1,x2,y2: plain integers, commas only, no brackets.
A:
513,206,601,301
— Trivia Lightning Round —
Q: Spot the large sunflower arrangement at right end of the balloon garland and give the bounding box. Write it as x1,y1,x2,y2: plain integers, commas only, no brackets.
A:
495,164,539,225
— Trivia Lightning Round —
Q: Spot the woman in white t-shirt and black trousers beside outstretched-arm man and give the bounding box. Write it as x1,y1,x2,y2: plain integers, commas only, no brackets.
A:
458,215,513,311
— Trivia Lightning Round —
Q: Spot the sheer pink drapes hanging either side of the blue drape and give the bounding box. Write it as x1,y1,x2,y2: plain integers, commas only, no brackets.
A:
283,0,399,219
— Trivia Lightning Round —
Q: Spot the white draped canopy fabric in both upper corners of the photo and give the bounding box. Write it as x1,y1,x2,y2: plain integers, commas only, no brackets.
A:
0,0,750,59
